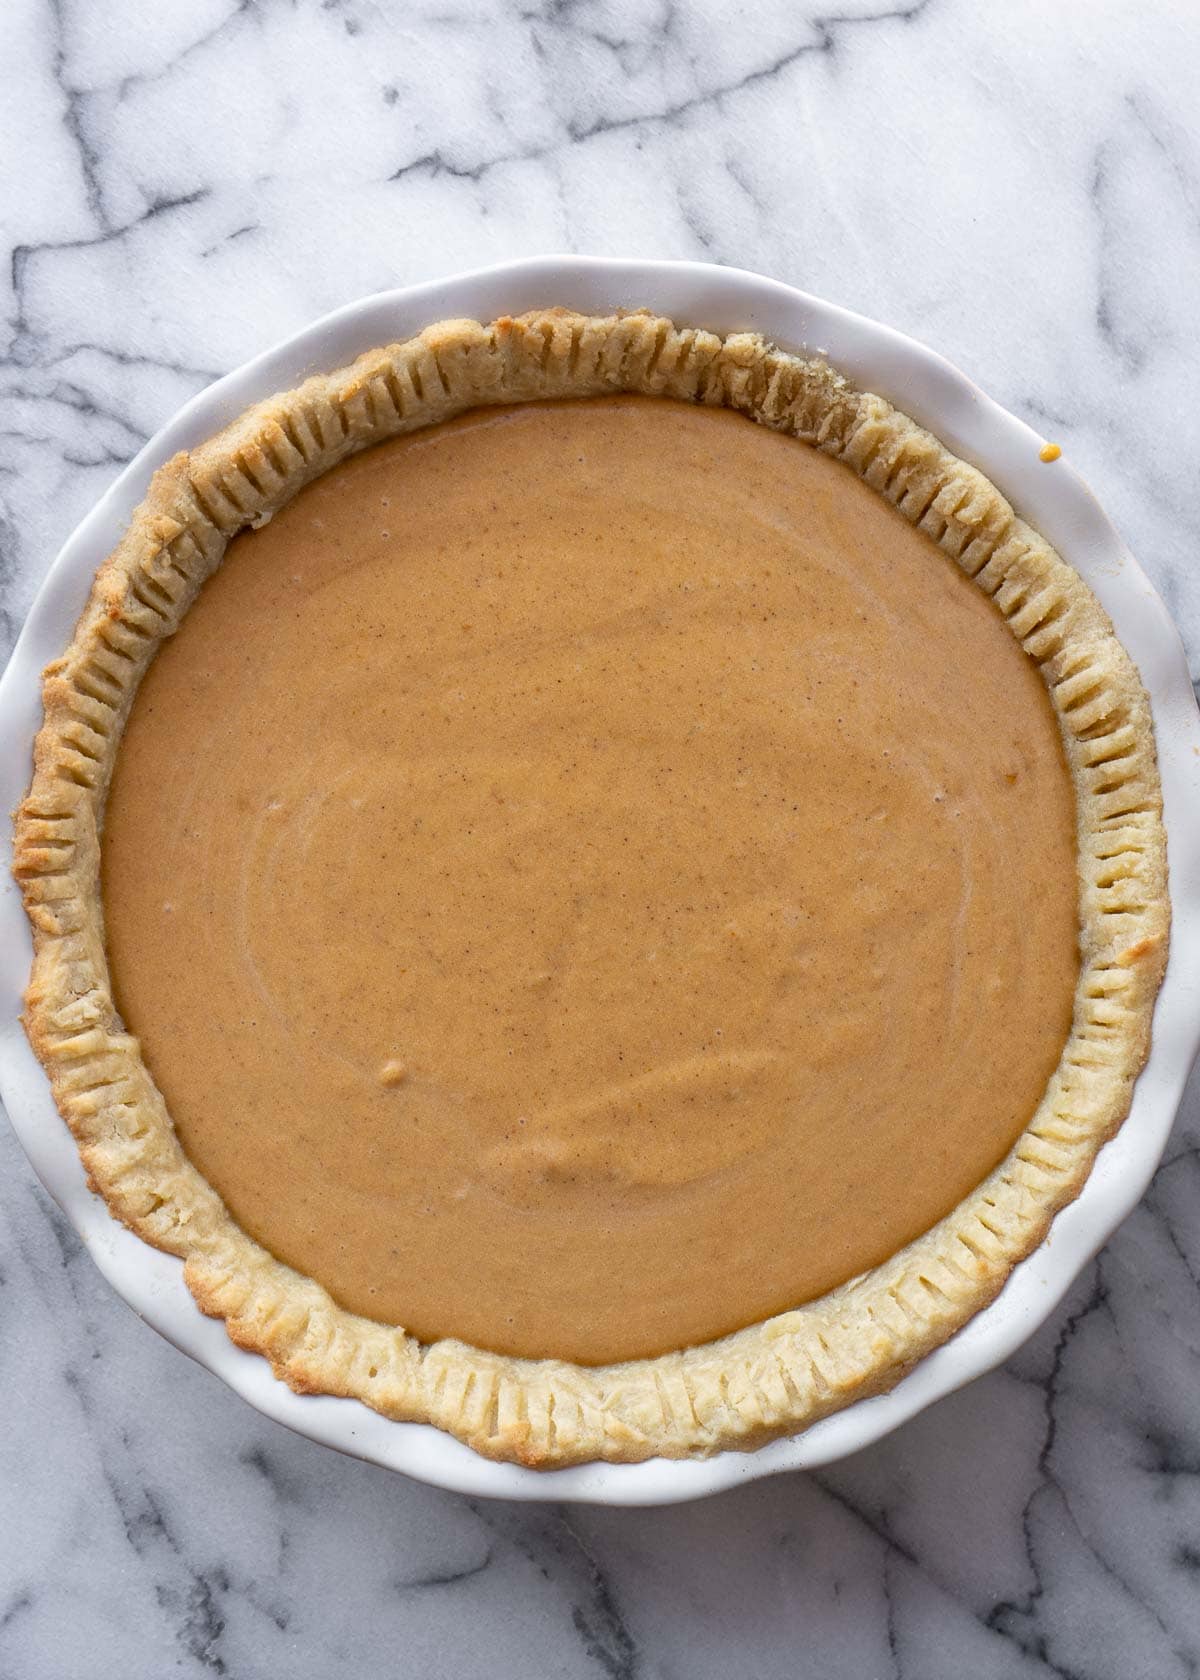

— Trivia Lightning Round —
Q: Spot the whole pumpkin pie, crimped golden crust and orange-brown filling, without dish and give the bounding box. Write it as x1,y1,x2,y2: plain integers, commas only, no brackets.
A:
17,311,1166,1465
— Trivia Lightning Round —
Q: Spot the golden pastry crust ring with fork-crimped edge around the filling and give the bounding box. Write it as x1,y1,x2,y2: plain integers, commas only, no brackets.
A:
15,309,1168,1467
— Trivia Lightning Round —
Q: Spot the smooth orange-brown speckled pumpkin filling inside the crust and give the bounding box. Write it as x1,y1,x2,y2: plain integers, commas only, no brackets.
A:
103,396,1079,1364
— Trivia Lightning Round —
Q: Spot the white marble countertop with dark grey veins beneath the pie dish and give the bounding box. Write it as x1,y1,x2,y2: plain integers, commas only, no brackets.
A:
0,0,1200,1680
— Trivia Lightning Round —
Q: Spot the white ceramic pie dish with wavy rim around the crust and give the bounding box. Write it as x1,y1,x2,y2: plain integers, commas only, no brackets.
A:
0,257,1200,1505
